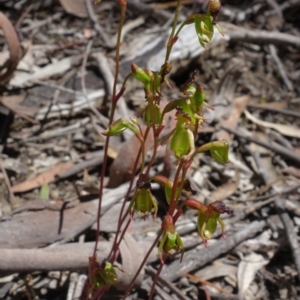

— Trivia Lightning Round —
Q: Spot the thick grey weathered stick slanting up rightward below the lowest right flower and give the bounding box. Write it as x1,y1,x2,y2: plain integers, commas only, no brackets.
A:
163,221,266,281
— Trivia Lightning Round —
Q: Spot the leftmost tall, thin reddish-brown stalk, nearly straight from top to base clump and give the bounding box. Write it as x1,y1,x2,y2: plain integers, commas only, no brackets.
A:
94,2,126,256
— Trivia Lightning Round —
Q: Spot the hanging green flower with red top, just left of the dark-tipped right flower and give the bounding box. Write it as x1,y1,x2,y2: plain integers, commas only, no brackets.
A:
158,215,184,263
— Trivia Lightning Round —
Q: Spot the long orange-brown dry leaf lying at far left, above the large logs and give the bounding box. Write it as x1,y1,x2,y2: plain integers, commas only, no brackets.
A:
12,163,73,193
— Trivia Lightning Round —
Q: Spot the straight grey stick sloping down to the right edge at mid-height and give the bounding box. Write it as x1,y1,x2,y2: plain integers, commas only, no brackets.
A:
221,126,300,164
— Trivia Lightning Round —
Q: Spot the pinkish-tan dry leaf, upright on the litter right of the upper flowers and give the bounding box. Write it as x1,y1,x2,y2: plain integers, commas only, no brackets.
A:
216,95,249,142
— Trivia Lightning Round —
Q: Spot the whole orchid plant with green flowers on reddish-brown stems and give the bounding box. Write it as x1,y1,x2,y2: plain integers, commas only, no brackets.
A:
85,0,232,299
